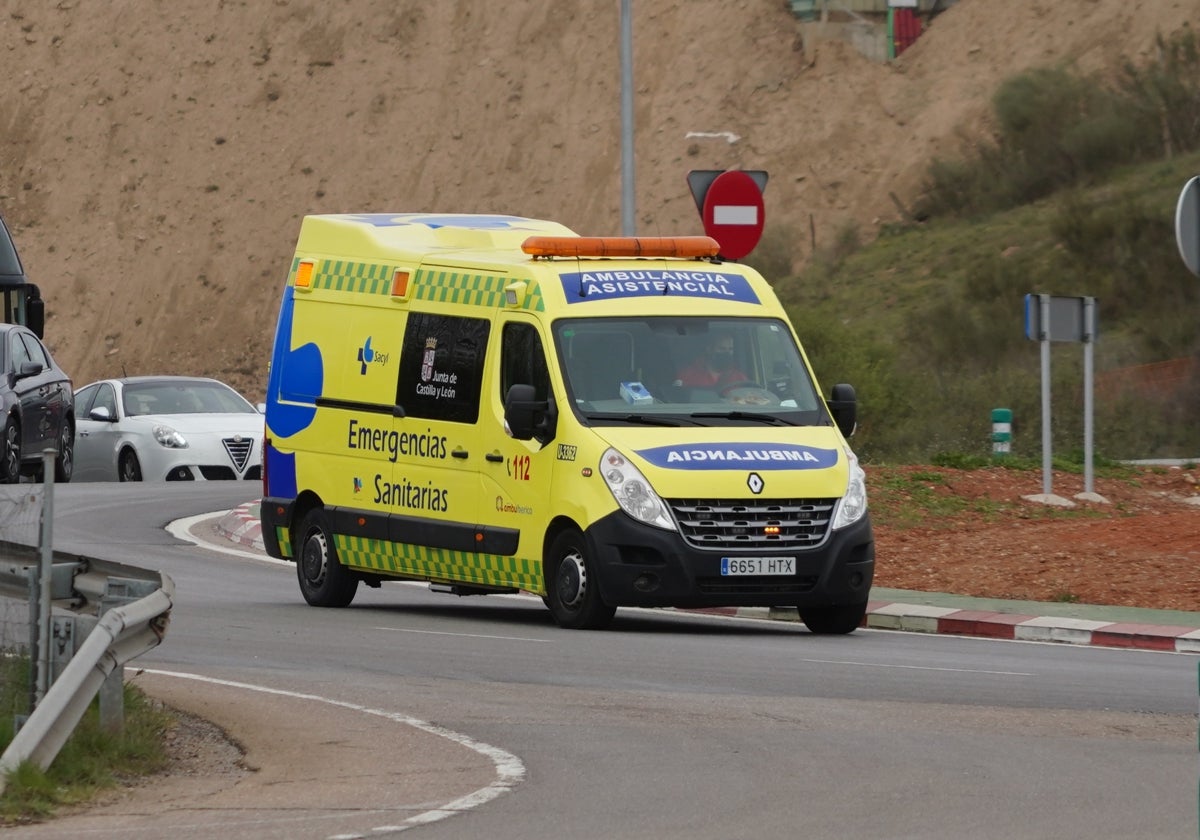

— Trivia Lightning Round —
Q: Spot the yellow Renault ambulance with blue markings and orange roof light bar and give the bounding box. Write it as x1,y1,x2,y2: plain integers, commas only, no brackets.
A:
262,214,875,634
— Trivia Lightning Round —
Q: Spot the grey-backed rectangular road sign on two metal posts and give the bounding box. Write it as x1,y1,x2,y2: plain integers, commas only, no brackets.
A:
1025,294,1097,496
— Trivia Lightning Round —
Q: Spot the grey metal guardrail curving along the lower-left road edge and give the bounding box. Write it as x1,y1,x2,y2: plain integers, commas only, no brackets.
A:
0,541,175,793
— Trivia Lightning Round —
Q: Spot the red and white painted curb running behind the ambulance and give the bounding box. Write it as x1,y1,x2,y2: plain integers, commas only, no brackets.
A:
216,500,1200,654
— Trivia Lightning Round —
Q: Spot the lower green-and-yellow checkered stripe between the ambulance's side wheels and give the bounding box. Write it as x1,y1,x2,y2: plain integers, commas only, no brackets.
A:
334,534,541,592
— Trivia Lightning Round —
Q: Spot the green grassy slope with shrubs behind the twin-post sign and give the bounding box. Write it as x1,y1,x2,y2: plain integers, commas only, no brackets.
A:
772,39,1200,463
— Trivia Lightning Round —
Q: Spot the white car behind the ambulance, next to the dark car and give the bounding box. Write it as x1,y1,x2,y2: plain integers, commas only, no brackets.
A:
73,376,264,481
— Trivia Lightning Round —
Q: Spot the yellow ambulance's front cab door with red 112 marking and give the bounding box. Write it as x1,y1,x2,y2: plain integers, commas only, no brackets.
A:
480,313,564,578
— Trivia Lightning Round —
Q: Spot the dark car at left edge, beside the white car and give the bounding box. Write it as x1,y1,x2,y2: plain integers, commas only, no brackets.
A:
0,324,74,484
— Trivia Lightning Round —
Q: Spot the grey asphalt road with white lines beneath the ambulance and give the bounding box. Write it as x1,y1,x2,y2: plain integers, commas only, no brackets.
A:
11,484,1198,840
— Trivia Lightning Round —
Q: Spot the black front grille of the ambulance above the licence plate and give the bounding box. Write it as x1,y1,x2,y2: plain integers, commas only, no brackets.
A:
667,499,838,550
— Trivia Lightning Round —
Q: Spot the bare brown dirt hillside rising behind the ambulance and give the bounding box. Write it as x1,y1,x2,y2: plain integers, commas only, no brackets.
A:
0,0,1200,398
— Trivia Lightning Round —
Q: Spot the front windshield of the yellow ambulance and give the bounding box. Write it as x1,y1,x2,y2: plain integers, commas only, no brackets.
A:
554,317,830,426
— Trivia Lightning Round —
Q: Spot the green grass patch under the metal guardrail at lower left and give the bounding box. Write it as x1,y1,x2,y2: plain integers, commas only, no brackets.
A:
0,656,173,827
